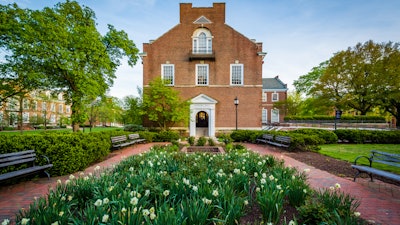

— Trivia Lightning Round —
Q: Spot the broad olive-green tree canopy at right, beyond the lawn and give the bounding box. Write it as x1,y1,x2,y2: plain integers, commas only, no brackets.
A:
295,40,400,126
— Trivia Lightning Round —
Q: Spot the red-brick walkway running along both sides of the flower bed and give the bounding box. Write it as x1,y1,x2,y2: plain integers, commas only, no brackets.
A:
0,143,400,225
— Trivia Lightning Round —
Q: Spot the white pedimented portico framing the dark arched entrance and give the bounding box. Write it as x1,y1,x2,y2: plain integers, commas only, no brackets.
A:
189,94,218,137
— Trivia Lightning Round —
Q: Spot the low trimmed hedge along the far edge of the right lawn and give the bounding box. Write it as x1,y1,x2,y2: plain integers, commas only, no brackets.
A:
335,129,400,144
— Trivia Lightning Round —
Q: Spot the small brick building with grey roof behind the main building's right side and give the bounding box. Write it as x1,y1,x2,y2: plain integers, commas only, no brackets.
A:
261,76,288,125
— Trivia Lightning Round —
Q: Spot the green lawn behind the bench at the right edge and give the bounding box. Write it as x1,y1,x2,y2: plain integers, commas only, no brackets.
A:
319,144,400,174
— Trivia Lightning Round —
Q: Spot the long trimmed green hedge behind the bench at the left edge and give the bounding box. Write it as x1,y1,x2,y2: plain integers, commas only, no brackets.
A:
0,131,126,176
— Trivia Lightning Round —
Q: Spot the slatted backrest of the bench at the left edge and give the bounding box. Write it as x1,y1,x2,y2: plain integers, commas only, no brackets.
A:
0,150,36,168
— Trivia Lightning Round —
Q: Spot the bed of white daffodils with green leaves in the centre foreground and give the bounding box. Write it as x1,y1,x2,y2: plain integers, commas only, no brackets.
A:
12,146,318,224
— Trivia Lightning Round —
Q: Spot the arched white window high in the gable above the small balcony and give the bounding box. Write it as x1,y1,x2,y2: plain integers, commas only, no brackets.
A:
192,28,212,54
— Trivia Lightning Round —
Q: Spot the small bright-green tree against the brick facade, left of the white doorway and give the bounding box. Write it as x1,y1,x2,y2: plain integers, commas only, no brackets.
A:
143,77,190,130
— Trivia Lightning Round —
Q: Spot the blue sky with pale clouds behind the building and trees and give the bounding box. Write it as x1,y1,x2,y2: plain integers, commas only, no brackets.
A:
0,0,400,99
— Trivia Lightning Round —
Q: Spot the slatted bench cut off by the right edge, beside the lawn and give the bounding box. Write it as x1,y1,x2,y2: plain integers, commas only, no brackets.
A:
351,150,400,181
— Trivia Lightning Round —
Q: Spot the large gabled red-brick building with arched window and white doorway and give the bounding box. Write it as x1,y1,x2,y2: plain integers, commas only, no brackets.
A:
141,3,266,137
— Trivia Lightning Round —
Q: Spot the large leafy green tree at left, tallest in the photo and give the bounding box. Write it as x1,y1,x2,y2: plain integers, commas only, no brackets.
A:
0,1,138,131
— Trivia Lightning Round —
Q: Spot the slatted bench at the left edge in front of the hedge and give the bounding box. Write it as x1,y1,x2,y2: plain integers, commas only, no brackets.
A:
0,150,53,183
